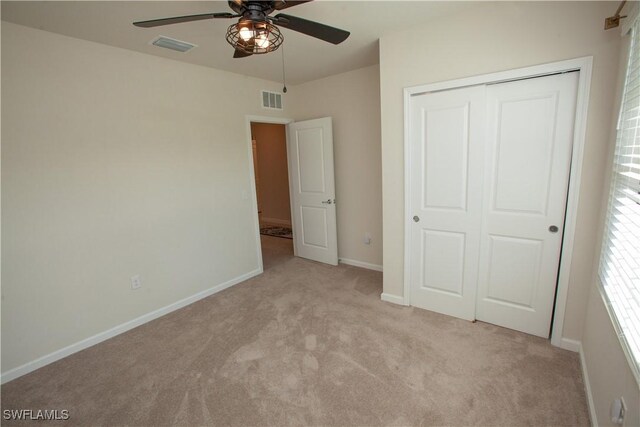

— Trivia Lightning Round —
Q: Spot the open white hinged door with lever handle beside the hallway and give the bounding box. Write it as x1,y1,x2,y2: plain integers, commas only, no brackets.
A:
287,117,338,265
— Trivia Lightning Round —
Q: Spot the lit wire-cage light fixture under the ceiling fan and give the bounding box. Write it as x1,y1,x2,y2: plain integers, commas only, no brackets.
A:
226,20,284,55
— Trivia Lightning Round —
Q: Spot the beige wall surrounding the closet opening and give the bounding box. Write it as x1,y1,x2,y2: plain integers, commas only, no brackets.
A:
380,2,620,340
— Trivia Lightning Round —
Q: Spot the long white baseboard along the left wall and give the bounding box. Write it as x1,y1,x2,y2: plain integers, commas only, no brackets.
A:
0,269,262,384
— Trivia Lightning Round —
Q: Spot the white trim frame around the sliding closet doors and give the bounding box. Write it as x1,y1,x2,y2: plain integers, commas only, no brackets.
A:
402,56,593,351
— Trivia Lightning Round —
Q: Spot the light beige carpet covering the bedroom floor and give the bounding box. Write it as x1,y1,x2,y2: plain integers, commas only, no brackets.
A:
2,237,589,426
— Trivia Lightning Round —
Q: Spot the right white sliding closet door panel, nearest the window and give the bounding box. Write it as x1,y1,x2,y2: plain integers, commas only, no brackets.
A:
476,73,578,337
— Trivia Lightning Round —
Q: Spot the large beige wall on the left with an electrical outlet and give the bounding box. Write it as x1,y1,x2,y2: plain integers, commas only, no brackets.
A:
2,22,280,372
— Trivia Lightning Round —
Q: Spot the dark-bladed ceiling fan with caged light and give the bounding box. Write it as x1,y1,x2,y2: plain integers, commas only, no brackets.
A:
133,0,350,58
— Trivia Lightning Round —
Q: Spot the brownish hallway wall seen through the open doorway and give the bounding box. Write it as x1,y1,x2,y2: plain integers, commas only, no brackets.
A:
251,123,291,225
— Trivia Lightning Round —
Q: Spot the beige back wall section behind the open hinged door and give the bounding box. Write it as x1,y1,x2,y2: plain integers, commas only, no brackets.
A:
287,65,382,265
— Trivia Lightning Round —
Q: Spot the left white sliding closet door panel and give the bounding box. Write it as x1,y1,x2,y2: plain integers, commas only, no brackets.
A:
408,86,485,320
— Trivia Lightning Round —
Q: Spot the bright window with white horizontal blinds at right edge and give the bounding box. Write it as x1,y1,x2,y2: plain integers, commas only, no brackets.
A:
599,19,640,378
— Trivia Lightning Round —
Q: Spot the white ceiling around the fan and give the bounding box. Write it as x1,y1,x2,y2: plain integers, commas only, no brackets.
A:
2,0,469,85
